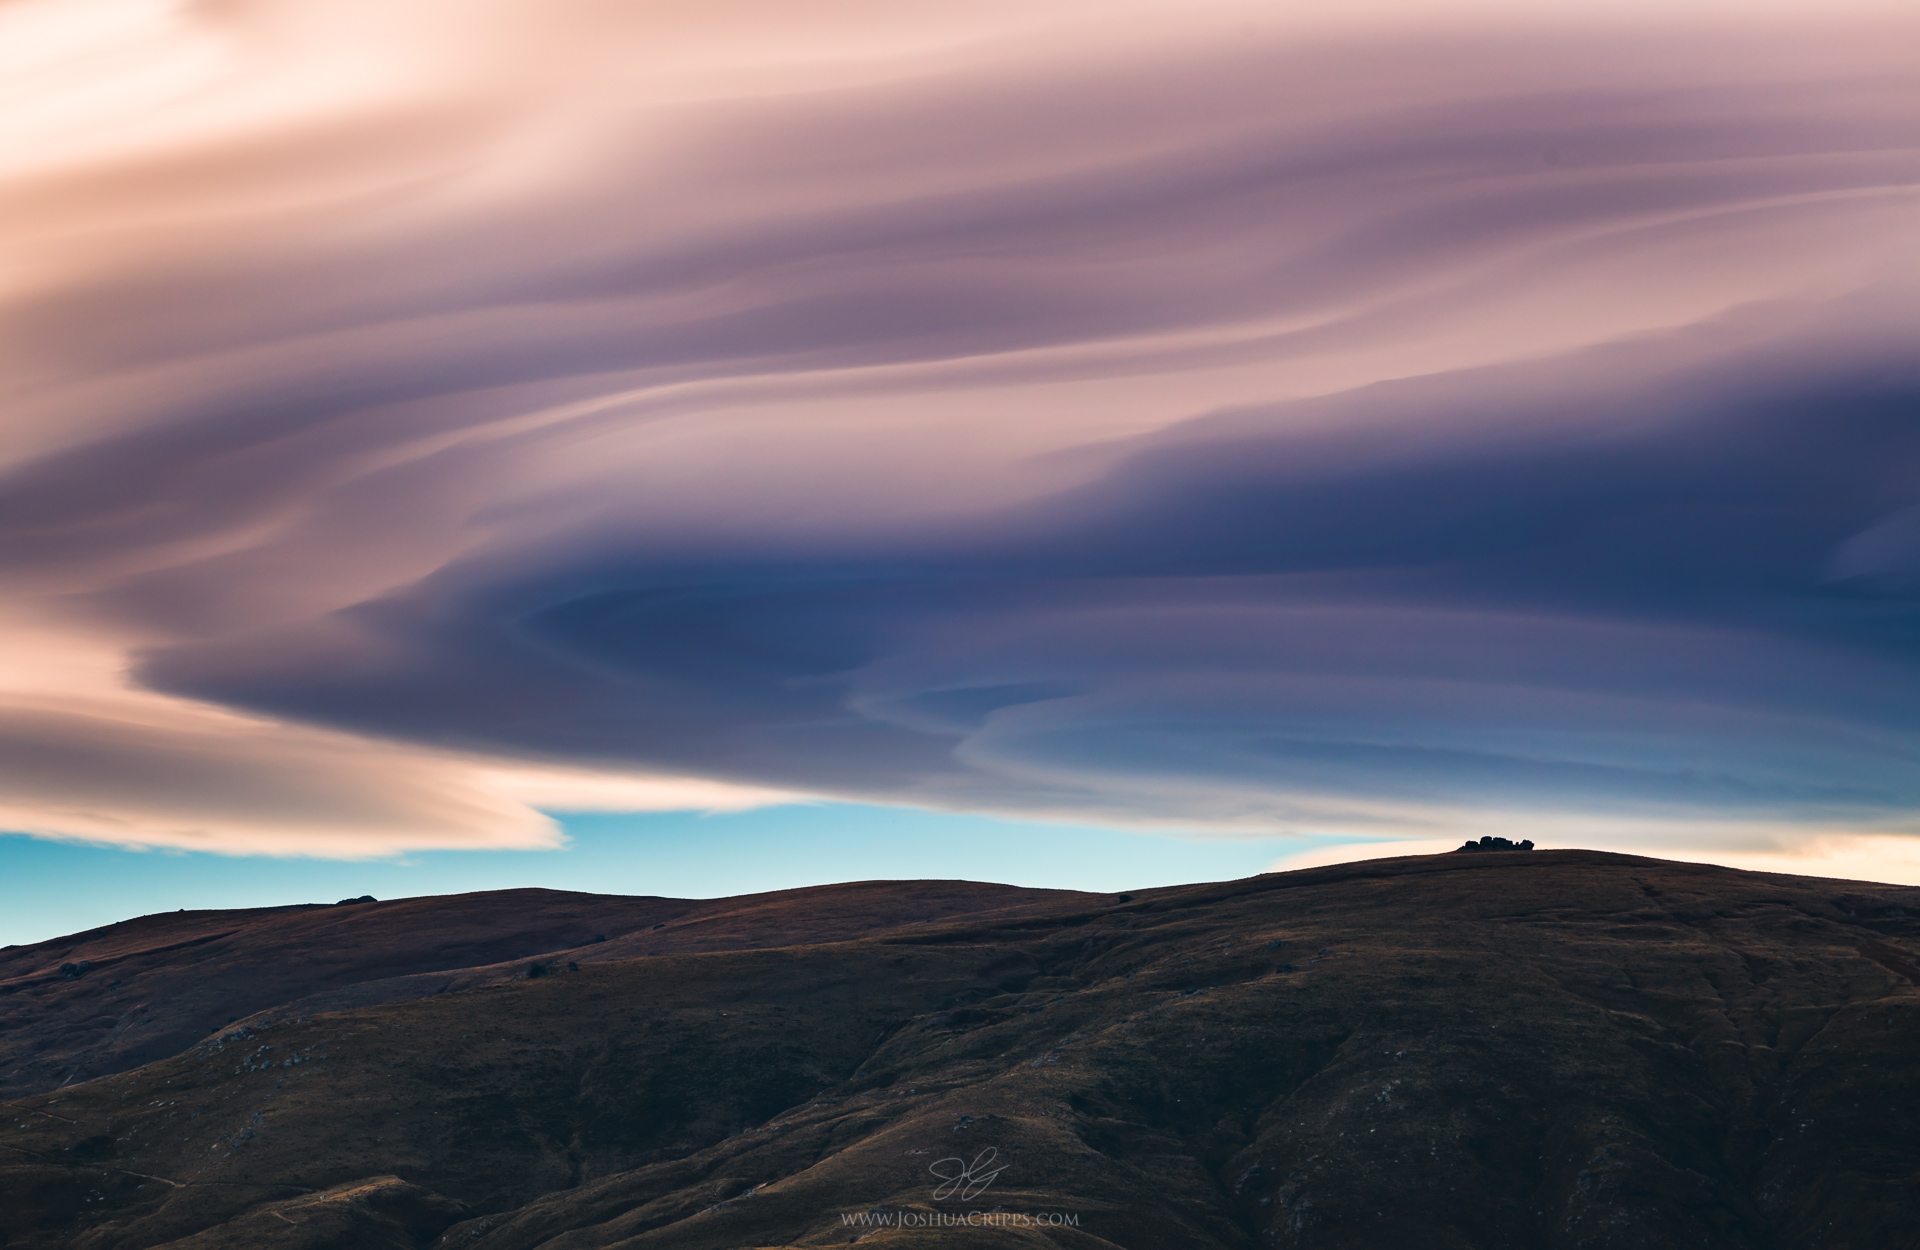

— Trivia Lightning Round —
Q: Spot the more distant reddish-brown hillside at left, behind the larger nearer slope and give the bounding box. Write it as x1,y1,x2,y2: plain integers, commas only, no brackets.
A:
0,881,1075,1098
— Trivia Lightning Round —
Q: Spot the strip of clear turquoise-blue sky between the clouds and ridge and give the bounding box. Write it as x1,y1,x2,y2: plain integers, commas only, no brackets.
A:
0,805,1313,945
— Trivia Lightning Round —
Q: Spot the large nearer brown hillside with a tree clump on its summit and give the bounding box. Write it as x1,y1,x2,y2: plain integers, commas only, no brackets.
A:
0,851,1920,1250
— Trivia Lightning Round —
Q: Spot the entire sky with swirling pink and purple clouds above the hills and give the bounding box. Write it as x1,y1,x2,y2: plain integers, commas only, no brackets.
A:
0,0,1920,937
